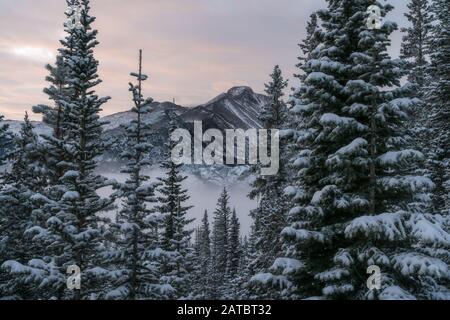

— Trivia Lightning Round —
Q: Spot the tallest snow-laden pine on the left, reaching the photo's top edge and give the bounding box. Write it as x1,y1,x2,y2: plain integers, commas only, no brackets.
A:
3,0,113,299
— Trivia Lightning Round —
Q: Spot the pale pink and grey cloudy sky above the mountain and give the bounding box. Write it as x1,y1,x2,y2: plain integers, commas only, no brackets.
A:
0,0,407,119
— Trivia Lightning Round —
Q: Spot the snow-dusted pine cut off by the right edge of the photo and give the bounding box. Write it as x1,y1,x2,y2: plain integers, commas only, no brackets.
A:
426,0,450,214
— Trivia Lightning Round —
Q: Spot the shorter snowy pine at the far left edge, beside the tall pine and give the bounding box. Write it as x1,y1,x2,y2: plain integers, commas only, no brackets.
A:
0,114,46,299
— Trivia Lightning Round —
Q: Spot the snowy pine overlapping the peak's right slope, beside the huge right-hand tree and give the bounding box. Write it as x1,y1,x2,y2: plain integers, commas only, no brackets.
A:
250,66,289,298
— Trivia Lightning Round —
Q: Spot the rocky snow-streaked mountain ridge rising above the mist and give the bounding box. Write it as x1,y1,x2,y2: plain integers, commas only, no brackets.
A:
0,87,269,171
